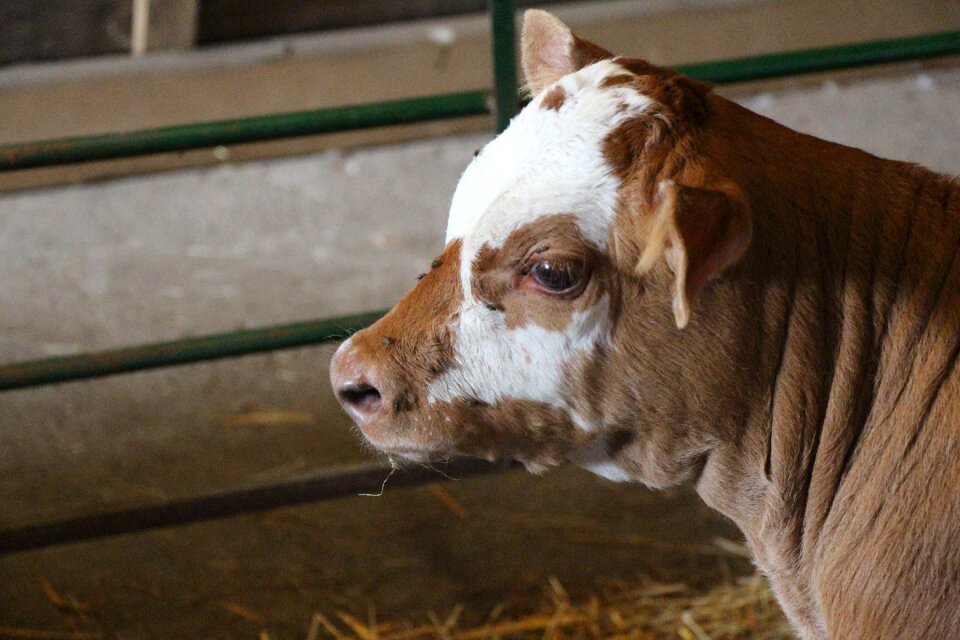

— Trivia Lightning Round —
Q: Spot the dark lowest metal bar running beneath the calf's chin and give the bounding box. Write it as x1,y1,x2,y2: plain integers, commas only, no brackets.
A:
0,459,514,554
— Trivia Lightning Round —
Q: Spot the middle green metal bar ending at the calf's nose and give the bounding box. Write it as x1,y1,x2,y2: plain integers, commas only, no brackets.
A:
0,311,385,391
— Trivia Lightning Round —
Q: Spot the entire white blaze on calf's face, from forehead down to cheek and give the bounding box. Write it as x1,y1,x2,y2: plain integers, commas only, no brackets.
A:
429,60,653,430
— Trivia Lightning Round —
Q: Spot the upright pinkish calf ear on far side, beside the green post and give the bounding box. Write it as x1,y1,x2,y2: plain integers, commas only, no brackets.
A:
520,9,613,95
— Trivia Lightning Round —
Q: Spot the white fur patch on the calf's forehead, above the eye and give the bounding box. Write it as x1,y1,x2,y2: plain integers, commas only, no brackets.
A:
447,60,653,250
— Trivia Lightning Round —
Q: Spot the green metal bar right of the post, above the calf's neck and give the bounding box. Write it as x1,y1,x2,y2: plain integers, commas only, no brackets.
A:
676,31,960,84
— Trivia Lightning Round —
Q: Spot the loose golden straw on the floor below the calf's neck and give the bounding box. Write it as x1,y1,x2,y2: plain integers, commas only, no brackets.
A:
307,576,794,640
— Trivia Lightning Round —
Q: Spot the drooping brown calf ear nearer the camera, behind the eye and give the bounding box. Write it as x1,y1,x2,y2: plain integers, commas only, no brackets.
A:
637,180,752,329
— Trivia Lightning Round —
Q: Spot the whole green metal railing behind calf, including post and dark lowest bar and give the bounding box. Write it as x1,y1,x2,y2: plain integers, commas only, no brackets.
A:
0,0,960,553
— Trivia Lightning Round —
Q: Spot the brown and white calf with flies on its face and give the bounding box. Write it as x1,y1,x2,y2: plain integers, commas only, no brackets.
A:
331,11,960,640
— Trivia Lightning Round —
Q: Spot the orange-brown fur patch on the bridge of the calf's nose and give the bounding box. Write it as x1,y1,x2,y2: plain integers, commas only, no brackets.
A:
353,240,463,400
